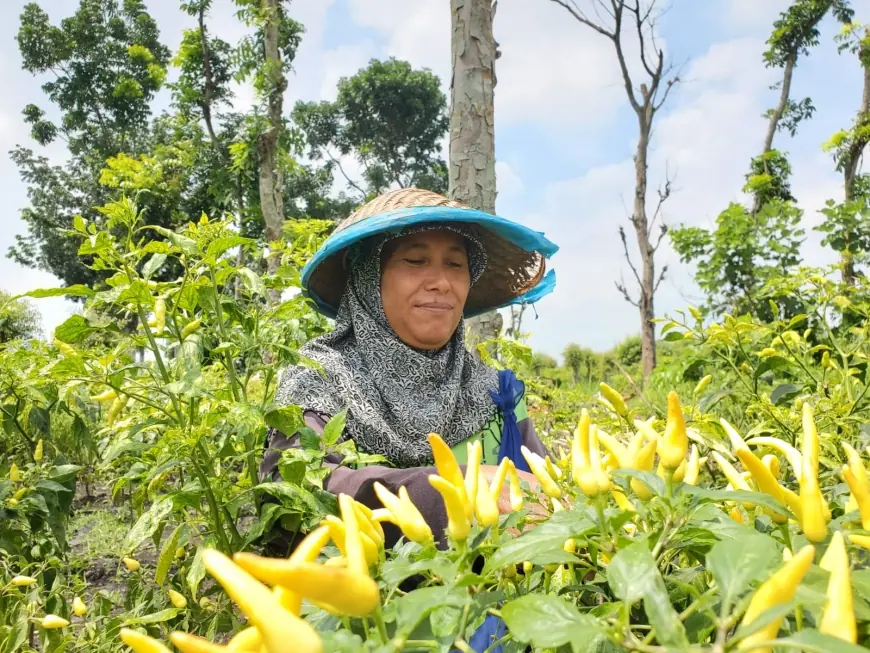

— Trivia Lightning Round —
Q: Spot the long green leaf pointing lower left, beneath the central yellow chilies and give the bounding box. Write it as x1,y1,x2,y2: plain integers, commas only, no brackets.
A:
483,510,595,575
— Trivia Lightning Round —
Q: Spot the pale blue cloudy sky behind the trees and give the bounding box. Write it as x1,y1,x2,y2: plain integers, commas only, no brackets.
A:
0,0,870,355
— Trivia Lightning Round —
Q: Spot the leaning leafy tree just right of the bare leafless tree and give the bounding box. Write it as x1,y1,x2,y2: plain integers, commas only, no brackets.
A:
670,0,852,319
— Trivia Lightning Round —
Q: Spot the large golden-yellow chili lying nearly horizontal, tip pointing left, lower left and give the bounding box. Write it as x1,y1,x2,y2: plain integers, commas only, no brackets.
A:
233,553,381,616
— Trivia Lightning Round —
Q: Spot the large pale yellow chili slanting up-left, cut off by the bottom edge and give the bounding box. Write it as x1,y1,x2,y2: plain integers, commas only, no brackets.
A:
200,549,324,653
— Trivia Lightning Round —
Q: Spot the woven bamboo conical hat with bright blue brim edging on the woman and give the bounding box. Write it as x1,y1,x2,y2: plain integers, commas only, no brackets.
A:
302,188,559,317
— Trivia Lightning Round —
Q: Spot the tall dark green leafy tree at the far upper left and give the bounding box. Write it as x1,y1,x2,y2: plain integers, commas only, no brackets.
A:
9,0,169,284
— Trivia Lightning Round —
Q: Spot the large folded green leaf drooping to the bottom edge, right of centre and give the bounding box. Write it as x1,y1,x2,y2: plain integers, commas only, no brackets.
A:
607,541,689,647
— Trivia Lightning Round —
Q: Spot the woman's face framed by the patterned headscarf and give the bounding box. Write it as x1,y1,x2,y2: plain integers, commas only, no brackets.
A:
381,230,471,349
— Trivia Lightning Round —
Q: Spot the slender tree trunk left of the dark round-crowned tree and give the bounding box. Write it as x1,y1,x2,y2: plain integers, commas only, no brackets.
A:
257,0,287,305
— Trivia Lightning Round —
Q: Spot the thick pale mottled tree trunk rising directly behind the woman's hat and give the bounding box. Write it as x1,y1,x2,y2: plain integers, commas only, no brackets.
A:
448,0,502,349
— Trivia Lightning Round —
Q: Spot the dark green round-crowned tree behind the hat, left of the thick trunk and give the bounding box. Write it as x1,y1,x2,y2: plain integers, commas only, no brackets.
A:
293,58,447,201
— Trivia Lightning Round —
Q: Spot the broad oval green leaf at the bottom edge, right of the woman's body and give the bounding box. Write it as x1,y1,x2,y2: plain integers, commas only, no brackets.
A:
501,594,602,651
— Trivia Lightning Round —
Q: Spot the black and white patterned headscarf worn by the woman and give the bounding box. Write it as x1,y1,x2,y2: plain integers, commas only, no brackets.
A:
275,224,498,467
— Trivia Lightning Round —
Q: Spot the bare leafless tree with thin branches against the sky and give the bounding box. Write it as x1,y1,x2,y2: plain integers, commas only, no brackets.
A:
551,0,679,379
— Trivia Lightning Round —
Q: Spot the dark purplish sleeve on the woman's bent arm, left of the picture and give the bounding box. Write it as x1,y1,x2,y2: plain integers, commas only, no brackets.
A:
260,411,447,547
